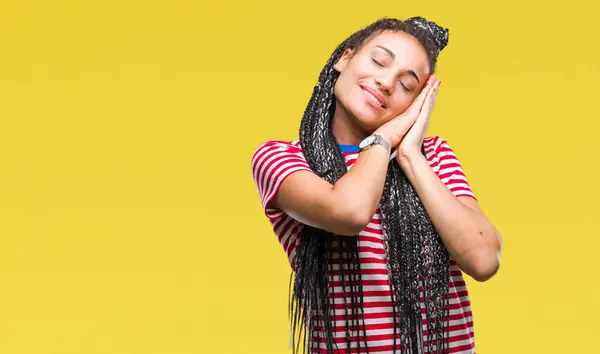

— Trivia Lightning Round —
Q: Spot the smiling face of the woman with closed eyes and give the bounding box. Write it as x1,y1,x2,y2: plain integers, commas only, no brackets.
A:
334,31,430,134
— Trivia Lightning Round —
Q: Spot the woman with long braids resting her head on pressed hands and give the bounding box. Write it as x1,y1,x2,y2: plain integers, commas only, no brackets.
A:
252,17,501,353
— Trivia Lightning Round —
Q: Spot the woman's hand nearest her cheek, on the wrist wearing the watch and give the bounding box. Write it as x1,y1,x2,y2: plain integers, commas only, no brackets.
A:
375,74,436,150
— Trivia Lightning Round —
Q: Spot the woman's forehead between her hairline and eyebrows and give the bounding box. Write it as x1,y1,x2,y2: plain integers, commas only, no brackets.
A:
361,31,429,72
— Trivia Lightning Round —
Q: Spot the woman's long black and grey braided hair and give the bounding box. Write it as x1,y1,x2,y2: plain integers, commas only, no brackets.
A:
289,17,449,353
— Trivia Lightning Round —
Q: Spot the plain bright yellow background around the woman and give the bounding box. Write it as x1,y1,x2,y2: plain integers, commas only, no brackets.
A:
0,0,600,354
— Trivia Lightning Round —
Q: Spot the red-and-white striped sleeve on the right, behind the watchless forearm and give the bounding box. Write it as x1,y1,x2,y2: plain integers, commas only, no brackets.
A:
435,138,477,199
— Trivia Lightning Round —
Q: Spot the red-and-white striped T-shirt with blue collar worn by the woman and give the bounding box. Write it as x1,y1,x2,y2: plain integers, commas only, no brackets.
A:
252,136,475,354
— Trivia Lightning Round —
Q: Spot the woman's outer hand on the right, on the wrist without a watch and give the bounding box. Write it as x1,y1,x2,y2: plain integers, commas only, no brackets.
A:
396,80,442,164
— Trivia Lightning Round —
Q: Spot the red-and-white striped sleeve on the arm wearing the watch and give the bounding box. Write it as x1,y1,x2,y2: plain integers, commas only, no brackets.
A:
252,140,312,219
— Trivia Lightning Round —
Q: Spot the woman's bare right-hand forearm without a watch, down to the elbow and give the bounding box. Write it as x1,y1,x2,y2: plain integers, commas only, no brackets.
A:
400,153,500,280
